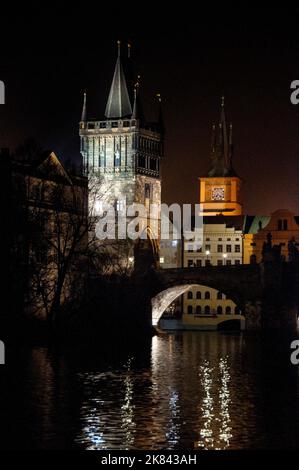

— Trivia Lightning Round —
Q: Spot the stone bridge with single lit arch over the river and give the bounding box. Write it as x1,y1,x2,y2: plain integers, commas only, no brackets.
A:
150,262,299,330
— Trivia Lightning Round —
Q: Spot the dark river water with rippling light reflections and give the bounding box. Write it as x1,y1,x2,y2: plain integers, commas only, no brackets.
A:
0,332,299,450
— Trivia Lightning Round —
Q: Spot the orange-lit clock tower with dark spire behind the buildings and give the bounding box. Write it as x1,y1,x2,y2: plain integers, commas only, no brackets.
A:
199,97,243,216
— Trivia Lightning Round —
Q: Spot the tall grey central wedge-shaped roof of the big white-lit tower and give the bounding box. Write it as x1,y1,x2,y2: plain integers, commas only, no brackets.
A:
105,41,132,119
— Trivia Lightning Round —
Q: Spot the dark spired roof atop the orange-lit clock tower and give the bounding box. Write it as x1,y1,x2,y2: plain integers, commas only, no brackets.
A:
208,96,237,177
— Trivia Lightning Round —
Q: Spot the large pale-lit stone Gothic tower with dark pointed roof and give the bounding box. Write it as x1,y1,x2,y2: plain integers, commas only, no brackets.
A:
79,42,164,262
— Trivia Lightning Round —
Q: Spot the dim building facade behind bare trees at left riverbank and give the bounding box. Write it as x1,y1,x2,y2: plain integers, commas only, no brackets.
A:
9,152,88,320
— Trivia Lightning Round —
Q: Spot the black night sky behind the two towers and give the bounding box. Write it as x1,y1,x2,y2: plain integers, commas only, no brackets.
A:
0,2,299,214
